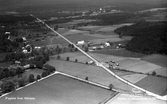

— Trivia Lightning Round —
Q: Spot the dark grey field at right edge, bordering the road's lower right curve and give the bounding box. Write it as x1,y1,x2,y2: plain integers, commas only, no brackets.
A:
136,76,167,95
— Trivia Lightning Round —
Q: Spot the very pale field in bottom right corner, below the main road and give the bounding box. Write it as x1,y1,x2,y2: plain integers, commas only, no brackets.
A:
106,94,166,104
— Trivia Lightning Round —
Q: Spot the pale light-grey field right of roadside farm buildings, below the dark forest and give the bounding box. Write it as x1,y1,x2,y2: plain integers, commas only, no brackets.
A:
117,59,161,73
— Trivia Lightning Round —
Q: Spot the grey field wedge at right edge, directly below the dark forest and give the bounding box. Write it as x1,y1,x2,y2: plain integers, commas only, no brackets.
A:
142,54,167,67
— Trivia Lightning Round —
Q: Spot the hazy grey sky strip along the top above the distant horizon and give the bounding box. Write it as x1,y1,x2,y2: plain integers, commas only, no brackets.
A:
0,0,167,10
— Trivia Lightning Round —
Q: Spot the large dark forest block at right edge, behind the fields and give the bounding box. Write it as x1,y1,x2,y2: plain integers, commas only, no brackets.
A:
115,22,167,54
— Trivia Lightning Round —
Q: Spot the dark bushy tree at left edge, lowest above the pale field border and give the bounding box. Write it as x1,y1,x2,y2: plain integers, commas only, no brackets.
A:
1,81,15,93
